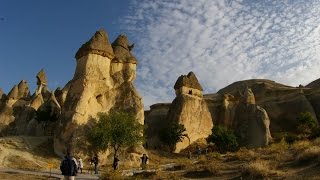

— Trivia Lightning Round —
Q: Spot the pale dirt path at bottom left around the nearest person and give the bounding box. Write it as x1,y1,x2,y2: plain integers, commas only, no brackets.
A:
0,167,99,180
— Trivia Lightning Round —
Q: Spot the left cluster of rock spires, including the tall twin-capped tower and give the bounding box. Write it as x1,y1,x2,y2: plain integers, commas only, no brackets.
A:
0,30,144,158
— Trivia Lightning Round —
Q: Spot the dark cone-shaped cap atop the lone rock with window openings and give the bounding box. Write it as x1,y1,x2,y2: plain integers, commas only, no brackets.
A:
174,71,203,91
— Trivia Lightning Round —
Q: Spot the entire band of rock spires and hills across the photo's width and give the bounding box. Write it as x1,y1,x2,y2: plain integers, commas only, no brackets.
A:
0,30,320,154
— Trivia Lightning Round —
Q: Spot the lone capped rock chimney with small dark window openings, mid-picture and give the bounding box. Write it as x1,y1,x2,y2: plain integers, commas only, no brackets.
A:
166,72,213,152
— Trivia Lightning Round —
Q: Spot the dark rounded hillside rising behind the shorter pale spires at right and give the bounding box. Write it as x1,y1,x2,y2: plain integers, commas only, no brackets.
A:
214,79,320,134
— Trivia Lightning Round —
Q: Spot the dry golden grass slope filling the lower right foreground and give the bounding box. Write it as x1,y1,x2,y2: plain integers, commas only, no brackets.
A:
103,139,320,179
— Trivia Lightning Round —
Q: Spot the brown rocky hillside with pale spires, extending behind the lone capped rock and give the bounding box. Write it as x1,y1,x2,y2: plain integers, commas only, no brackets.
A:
145,79,320,150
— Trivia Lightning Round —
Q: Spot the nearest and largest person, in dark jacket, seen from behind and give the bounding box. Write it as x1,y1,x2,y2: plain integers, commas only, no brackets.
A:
60,152,77,180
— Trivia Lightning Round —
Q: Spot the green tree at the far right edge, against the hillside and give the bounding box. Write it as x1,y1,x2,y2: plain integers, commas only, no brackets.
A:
297,112,318,135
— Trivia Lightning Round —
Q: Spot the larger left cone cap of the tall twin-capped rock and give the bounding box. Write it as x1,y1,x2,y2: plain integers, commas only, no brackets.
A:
75,29,114,59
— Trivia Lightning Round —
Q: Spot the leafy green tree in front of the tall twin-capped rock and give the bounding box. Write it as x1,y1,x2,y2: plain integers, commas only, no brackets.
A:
87,112,143,157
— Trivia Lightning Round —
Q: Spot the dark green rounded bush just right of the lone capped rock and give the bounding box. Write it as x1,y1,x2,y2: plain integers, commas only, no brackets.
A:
208,125,239,152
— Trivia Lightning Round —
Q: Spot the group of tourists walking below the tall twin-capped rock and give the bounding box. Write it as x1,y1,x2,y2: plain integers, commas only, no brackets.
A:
60,151,149,180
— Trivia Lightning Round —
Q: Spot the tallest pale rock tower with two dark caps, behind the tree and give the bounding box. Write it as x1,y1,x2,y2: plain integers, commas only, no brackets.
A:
54,30,144,154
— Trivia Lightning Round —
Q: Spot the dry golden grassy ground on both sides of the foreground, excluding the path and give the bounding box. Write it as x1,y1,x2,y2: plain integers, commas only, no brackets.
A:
0,137,320,179
